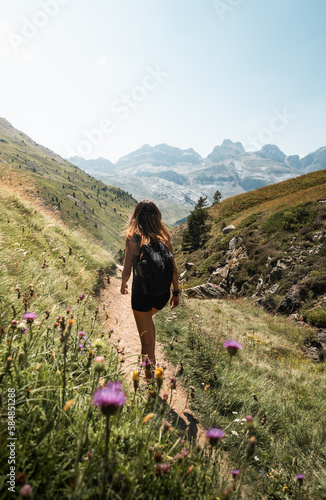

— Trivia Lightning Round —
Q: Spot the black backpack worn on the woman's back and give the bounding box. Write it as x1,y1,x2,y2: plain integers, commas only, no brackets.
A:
137,241,173,297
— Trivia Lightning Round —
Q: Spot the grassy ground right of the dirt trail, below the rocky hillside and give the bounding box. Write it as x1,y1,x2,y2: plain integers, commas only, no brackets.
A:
158,299,326,499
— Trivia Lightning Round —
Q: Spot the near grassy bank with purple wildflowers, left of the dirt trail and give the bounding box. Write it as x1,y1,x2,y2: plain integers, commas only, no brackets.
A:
0,177,230,500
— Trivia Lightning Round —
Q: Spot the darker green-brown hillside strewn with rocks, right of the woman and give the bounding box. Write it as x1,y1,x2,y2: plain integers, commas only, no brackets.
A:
174,170,326,326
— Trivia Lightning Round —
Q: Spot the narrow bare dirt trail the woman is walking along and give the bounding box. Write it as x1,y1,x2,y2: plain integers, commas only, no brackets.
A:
102,277,205,444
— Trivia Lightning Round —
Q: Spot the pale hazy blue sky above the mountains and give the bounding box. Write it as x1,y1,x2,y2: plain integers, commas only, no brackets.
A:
0,0,326,161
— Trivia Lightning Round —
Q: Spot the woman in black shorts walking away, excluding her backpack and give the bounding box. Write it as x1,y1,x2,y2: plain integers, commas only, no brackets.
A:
120,200,179,378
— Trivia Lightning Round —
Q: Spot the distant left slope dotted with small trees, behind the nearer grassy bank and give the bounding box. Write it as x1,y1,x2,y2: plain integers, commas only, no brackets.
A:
0,118,136,253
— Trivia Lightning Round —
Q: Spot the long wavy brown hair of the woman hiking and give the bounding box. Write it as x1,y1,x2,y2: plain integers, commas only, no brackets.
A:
126,200,171,246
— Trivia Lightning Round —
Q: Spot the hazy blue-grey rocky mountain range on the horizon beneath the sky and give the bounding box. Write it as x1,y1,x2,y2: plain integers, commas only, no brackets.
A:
69,139,326,224
